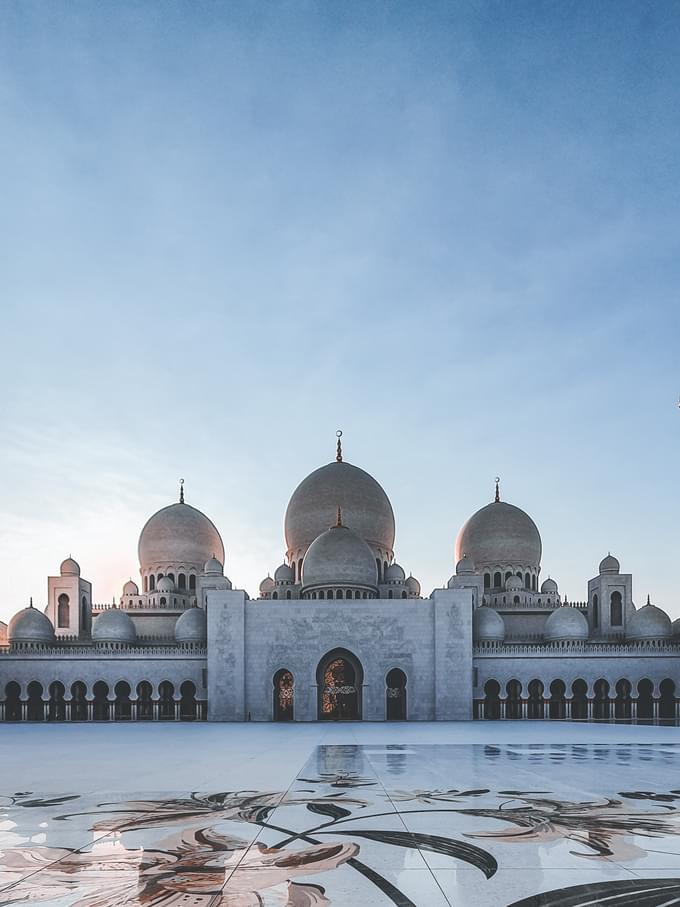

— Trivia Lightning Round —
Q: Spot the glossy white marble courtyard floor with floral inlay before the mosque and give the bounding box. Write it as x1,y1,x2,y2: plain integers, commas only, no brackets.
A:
0,722,680,907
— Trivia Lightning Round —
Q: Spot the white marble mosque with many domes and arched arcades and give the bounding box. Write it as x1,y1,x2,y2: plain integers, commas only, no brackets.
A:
0,433,680,724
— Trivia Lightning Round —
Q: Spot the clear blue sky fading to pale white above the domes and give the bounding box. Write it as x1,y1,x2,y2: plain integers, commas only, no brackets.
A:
0,0,680,620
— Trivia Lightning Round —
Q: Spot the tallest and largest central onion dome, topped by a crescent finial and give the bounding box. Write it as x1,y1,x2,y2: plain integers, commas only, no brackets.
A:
284,440,395,557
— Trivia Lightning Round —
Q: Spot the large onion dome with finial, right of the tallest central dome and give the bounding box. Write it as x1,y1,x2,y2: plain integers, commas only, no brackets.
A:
456,484,542,571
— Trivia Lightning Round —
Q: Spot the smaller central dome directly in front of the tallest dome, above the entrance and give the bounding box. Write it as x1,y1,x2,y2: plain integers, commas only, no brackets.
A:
302,512,378,592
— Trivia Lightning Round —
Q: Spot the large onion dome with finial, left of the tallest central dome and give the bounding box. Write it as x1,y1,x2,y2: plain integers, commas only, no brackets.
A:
137,492,224,572
